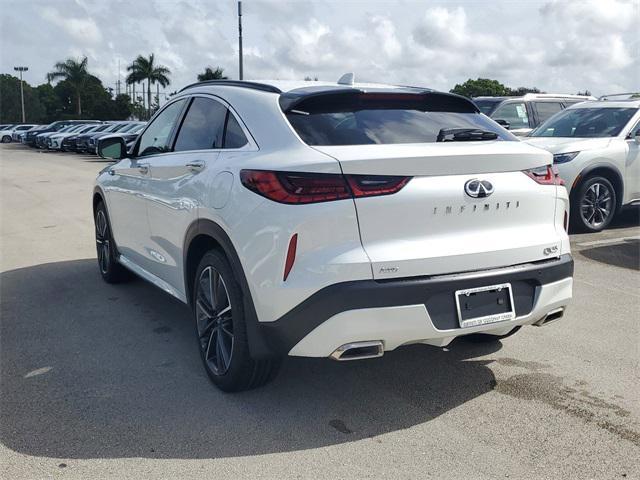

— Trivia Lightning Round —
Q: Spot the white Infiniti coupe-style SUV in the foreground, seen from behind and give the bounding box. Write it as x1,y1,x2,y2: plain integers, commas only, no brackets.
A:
93,76,573,391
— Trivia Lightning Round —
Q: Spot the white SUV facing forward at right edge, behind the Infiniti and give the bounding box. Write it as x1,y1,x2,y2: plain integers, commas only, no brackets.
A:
525,97,640,232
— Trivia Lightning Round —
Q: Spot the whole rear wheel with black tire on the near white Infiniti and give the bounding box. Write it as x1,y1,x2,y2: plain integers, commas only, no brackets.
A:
191,250,280,392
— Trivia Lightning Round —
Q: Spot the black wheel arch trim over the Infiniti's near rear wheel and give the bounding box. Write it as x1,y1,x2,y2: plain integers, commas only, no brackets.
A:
182,218,278,360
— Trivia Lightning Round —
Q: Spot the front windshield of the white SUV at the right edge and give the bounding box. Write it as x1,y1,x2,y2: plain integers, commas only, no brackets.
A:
530,107,638,138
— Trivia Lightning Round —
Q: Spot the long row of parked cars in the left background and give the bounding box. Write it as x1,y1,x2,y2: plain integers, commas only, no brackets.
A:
8,120,145,154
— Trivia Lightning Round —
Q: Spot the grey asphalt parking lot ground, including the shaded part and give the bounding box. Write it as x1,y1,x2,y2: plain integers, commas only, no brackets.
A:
0,144,640,479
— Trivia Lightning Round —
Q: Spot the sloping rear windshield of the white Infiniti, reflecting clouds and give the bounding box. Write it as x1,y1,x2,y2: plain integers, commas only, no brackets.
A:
285,93,515,145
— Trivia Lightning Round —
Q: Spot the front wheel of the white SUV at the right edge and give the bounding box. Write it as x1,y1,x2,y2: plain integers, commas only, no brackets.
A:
571,175,618,233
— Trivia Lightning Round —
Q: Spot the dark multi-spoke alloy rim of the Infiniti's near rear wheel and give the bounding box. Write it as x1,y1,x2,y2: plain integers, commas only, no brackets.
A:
196,266,234,375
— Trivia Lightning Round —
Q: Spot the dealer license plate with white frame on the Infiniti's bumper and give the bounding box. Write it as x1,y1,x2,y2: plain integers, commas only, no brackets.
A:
455,283,516,328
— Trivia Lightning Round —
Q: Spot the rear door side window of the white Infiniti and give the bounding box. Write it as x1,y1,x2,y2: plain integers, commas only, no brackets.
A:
174,97,227,152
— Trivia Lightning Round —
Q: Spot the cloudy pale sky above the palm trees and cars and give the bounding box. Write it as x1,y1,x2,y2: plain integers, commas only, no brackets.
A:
0,0,640,95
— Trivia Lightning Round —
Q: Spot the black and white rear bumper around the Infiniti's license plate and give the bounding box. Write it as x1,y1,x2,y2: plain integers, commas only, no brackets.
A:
260,255,573,357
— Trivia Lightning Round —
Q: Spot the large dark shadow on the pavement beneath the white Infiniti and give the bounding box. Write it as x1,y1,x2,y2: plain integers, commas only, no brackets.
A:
0,259,501,459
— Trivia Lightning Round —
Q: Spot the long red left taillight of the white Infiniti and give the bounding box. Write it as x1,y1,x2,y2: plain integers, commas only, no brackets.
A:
240,170,411,204
